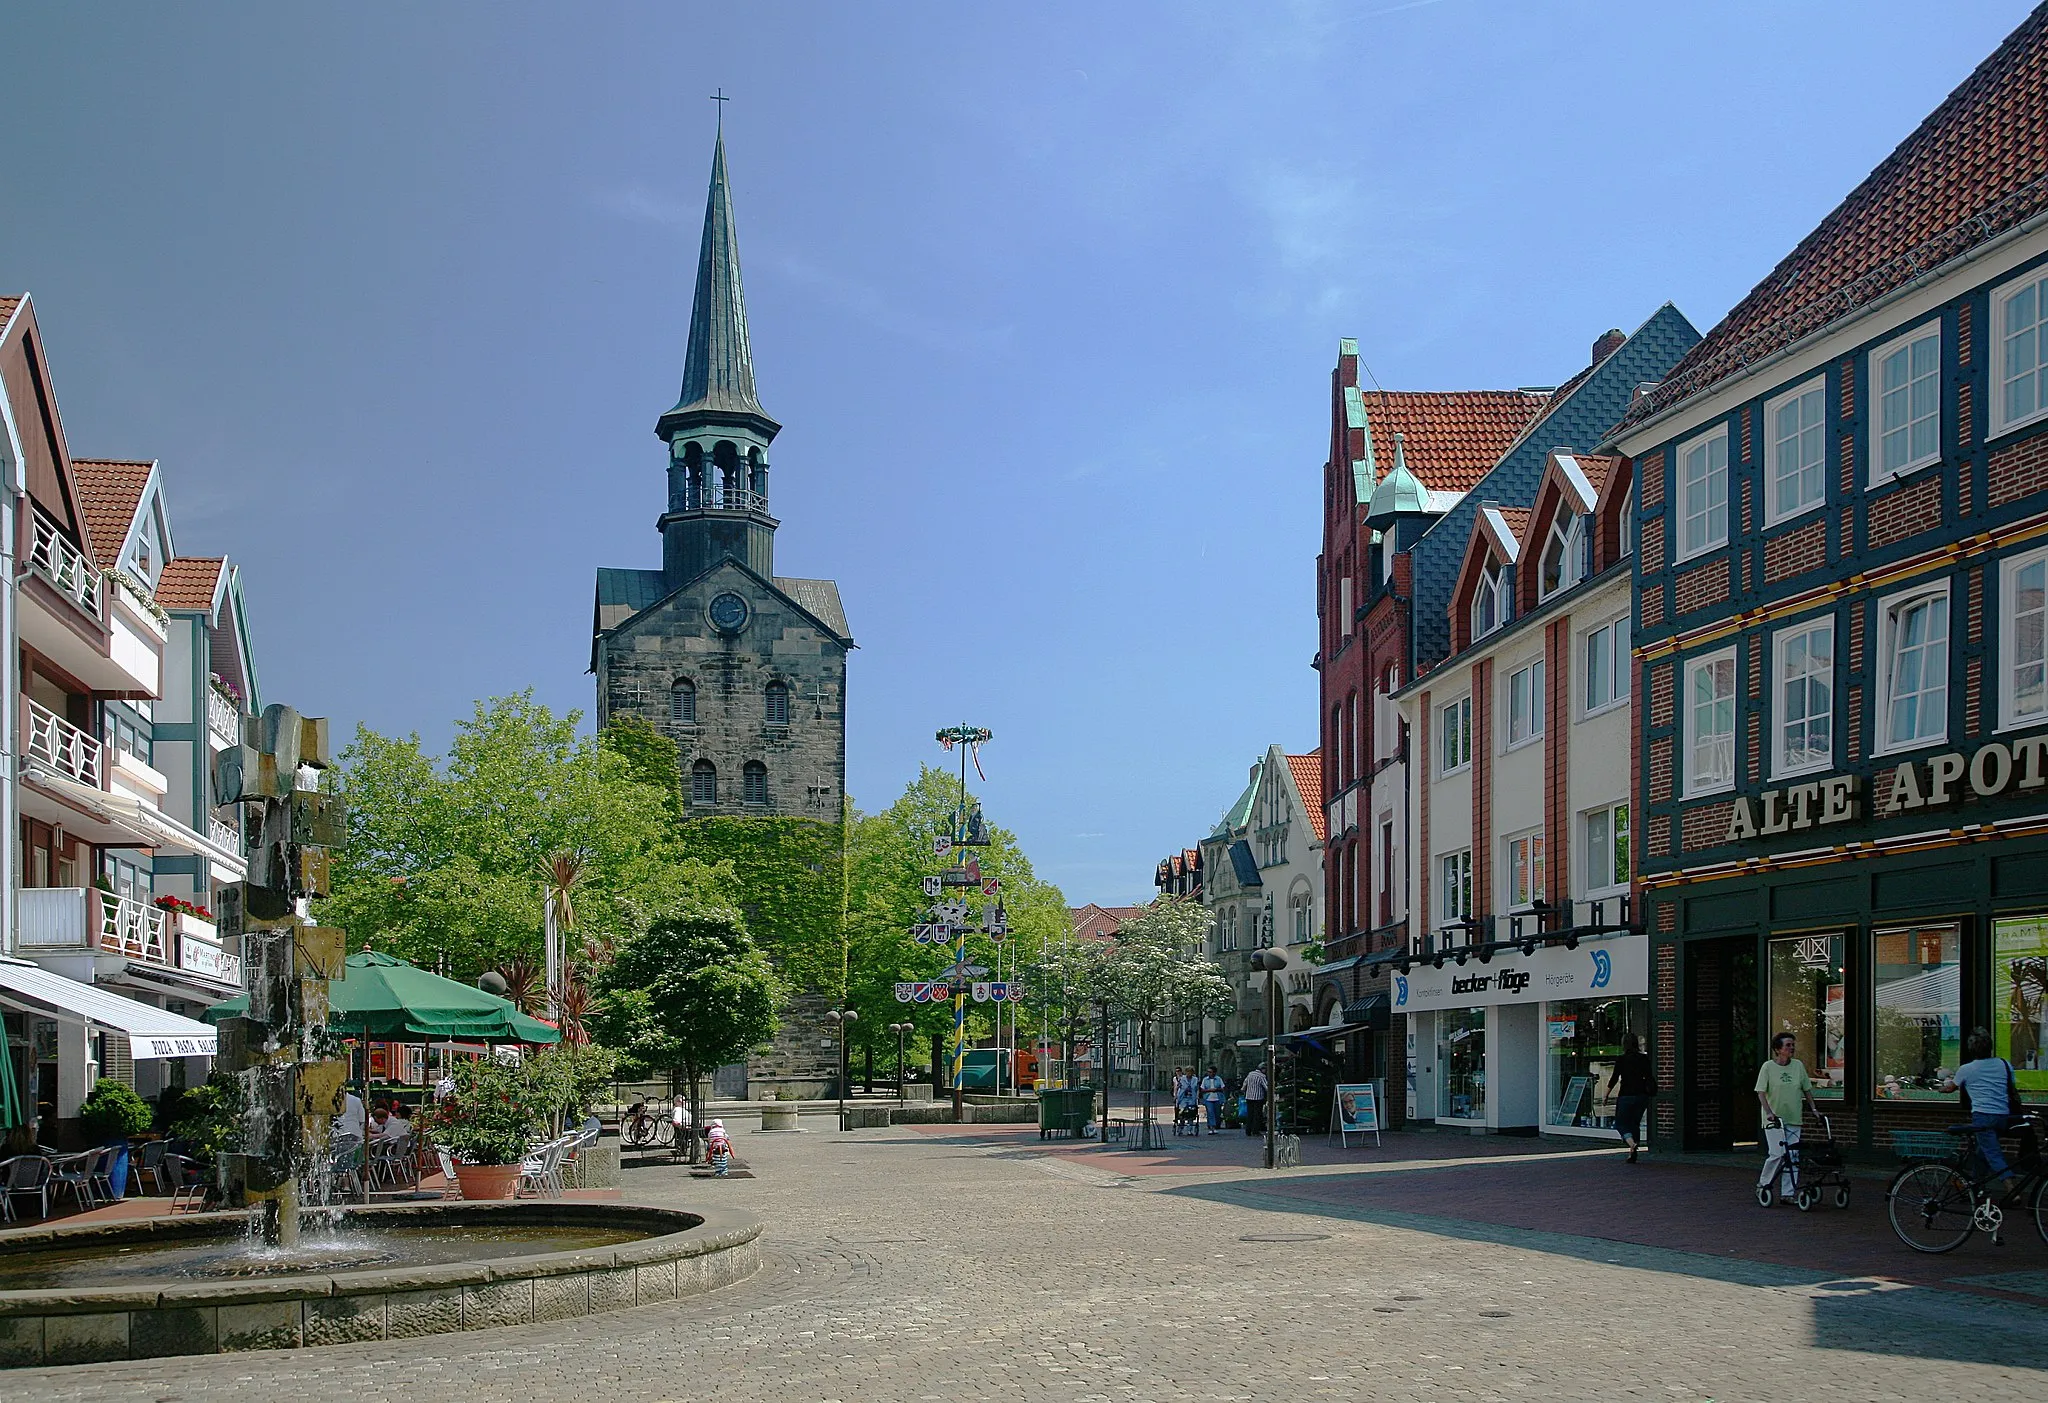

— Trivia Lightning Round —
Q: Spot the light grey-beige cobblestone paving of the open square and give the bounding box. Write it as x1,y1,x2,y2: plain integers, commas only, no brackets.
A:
0,1129,2048,1403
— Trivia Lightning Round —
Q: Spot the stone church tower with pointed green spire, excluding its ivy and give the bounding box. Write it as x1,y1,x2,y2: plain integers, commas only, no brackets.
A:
590,122,854,1096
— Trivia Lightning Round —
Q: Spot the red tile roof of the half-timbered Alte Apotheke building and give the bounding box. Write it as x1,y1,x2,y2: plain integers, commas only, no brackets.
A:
1624,6,2048,422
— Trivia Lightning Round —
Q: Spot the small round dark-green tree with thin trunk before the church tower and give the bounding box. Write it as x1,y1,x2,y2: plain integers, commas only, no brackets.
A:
592,905,782,1124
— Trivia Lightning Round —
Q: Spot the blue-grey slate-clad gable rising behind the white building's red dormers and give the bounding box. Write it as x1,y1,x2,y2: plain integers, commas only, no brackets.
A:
1409,303,1700,678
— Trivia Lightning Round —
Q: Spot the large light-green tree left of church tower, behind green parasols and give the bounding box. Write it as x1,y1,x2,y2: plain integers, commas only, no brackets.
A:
319,692,731,979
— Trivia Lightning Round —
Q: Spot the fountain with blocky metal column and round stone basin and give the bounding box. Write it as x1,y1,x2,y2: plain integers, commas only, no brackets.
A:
0,707,760,1366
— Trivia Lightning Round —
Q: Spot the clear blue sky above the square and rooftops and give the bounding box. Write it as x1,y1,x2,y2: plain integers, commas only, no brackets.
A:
0,0,2028,903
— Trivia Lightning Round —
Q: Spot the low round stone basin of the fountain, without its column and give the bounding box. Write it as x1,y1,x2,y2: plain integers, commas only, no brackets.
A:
0,1200,760,1366
